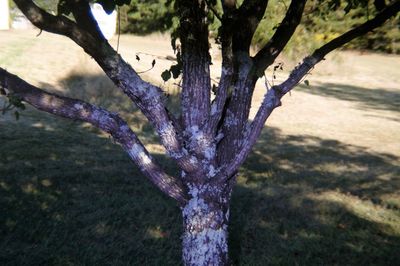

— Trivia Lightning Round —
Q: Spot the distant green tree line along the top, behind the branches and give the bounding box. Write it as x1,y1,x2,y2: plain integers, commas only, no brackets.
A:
10,0,400,53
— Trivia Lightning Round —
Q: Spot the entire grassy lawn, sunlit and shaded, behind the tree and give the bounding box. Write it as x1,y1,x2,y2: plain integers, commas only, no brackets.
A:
0,32,400,265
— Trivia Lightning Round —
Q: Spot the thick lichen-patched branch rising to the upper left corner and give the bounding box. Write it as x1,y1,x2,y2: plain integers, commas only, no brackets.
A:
15,0,197,172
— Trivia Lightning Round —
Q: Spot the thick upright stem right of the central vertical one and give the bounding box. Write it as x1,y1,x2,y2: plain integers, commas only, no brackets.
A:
211,0,268,165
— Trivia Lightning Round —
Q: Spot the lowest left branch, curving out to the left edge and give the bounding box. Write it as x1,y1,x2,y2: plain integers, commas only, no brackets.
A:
0,68,187,204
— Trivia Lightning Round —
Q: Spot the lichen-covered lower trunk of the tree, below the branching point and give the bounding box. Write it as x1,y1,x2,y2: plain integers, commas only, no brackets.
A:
182,185,229,266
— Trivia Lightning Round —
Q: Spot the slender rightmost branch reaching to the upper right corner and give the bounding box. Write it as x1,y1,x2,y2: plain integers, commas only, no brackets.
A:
220,1,400,180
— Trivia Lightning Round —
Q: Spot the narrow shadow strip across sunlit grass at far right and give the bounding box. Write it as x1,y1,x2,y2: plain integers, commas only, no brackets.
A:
299,83,400,112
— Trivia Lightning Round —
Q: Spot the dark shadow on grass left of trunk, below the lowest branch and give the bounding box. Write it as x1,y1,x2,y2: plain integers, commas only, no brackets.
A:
0,111,181,265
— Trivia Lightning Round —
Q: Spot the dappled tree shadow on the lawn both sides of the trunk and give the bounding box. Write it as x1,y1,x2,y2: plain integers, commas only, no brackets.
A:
0,73,400,265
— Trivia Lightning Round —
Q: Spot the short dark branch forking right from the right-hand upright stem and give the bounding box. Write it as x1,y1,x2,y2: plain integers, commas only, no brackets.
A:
254,0,307,74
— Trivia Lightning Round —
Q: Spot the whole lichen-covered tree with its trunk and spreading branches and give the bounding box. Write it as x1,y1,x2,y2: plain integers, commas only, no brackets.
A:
0,0,400,265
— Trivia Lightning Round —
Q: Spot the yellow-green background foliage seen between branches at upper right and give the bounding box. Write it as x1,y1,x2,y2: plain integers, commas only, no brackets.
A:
253,0,400,56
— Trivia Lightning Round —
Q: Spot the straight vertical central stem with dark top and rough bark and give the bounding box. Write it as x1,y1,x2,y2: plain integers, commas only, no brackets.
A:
178,0,211,129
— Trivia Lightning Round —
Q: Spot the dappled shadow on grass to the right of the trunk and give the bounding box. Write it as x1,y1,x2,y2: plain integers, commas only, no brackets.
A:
230,128,400,265
